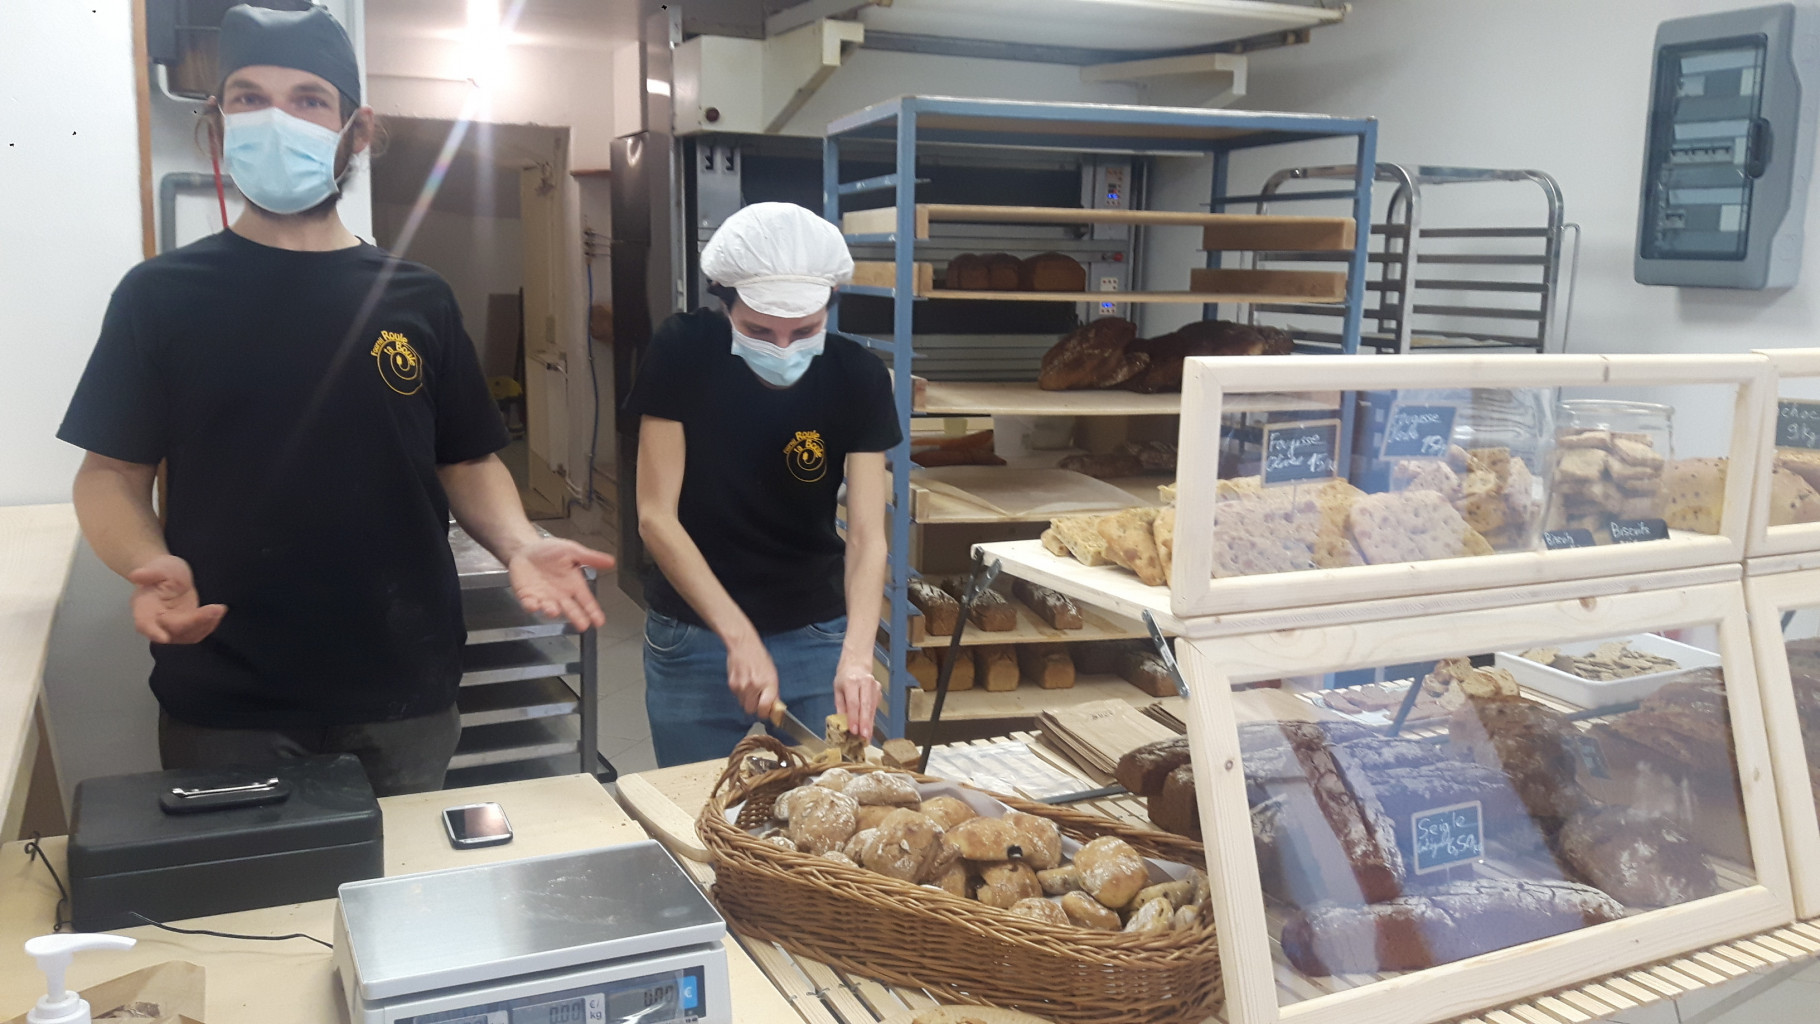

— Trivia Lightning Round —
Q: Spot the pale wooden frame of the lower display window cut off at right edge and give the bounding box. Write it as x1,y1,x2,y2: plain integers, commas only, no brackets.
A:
1744,567,1820,920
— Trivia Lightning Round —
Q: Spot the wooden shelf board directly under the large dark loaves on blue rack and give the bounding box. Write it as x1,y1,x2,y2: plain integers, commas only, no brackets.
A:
915,380,1340,417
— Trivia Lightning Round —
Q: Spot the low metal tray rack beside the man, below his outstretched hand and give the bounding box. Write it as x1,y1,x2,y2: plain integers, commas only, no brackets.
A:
450,527,601,788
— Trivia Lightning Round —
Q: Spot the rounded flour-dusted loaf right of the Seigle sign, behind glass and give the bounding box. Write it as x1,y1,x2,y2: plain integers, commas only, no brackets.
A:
1560,808,1718,906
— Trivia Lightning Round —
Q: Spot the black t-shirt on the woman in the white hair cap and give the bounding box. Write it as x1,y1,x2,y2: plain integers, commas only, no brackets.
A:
626,309,903,633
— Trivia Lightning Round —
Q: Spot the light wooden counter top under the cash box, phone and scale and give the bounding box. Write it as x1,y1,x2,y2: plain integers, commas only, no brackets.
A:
0,775,803,1024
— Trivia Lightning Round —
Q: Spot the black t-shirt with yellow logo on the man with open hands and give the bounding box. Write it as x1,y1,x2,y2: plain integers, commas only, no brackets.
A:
58,231,508,729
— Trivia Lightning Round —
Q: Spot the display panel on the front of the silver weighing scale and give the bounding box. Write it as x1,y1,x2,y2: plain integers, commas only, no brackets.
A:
409,968,708,1024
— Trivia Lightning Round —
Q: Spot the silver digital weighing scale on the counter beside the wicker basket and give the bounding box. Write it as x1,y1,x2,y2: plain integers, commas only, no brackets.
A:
335,840,733,1024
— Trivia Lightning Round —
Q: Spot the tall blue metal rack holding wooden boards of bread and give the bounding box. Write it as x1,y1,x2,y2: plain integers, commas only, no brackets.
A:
823,96,1378,735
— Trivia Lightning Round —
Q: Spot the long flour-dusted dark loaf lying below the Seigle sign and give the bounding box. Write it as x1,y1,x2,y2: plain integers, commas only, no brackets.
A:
1283,878,1623,977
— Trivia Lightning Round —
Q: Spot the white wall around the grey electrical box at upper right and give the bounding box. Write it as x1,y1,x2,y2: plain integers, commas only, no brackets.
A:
1203,0,1820,353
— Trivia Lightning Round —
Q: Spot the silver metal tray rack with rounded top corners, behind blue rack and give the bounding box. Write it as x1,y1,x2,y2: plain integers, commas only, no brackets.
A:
1249,164,1578,355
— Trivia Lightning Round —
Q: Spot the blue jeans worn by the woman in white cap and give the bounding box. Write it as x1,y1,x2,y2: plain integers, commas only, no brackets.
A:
644,611,846,768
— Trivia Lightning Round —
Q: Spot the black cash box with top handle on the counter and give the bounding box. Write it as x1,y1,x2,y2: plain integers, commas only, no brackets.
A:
69,755,386,931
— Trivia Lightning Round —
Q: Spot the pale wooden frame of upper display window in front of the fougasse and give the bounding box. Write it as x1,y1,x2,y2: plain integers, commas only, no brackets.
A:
1154,355,1775,618
